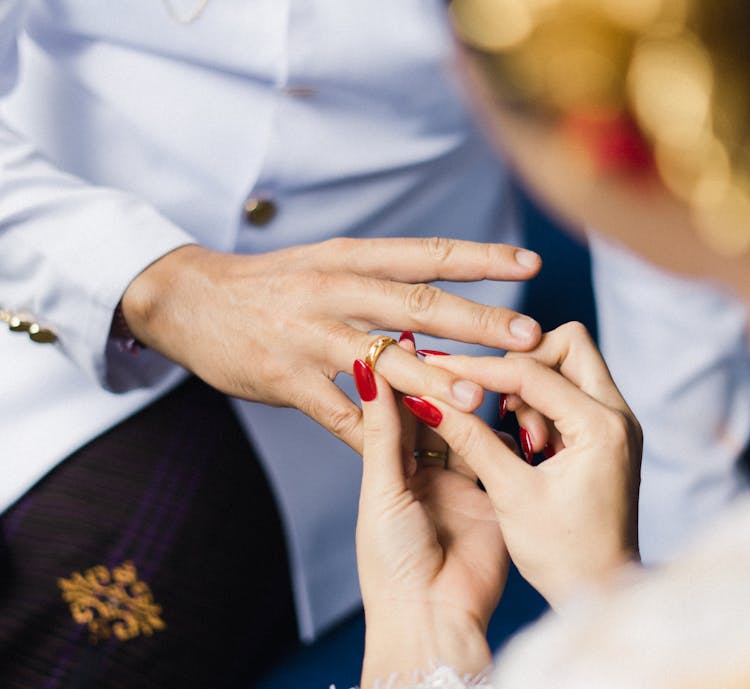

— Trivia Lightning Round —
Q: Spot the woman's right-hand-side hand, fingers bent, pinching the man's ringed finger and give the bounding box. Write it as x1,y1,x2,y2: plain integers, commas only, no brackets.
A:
418,324,642,607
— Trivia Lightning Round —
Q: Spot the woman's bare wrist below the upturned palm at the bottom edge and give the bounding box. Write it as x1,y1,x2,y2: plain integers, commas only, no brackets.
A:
361,603,492,689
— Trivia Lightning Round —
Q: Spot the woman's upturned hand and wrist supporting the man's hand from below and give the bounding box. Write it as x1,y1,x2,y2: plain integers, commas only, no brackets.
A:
357,358,509,689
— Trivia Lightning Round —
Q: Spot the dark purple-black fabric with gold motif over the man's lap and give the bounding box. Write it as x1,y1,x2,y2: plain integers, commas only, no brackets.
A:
0,379,296,689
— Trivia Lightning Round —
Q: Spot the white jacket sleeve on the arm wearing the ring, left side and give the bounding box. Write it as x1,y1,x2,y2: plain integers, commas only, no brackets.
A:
0,0,194,390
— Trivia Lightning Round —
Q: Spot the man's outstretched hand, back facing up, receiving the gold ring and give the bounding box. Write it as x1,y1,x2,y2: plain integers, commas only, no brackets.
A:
121,238,541,451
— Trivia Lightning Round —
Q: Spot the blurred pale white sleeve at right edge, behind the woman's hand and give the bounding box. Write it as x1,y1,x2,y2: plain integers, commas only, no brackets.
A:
590,235,750,562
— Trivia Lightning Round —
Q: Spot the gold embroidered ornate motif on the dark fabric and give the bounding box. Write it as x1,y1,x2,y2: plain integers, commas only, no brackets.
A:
57,560,166,643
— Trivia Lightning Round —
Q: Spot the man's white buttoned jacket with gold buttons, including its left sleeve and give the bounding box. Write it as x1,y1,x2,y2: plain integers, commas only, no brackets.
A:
0,0,520,638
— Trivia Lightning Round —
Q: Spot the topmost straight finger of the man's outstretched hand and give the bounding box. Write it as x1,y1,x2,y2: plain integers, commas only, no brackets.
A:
318,237,542,282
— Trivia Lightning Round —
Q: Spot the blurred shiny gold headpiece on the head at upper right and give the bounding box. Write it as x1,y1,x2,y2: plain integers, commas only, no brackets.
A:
450,0,750,257
